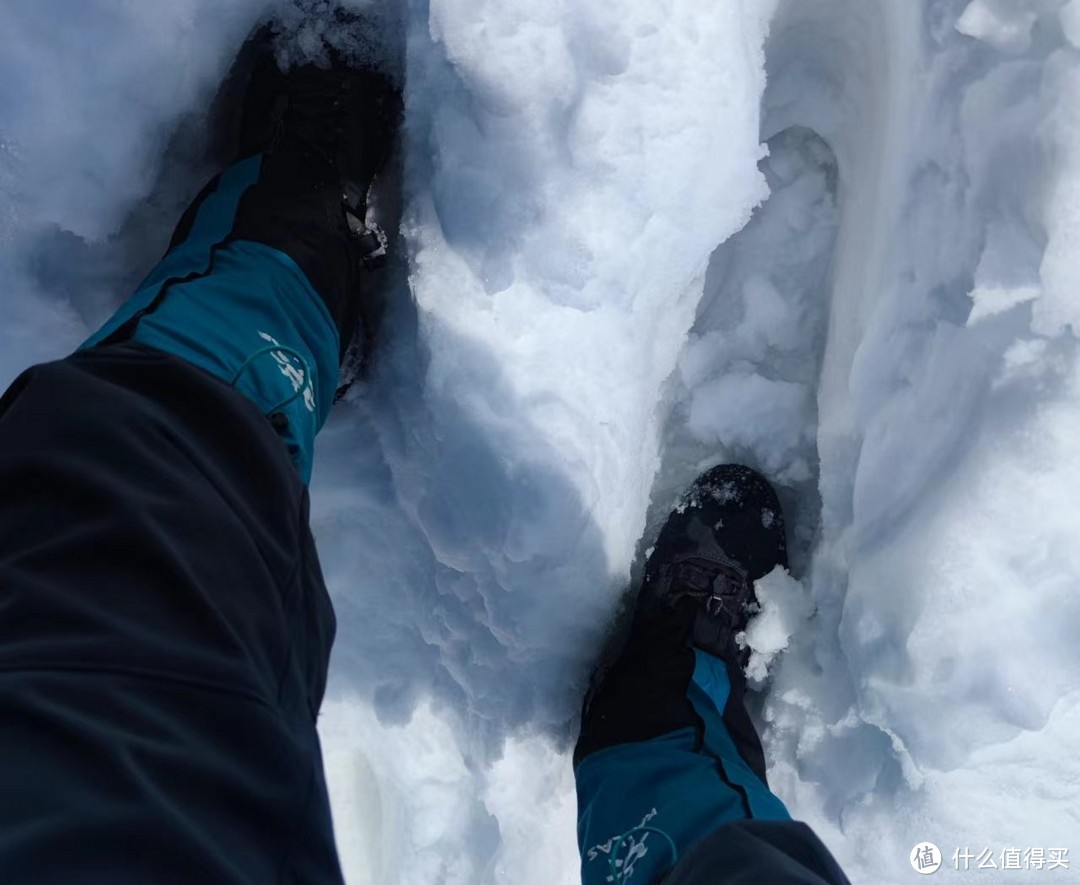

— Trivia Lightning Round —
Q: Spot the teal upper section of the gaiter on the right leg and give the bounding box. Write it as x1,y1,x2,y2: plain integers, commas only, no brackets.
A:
576,652,791,885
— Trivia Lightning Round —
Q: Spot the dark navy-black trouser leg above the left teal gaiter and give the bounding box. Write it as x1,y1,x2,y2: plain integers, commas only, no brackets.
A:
0,345,341,885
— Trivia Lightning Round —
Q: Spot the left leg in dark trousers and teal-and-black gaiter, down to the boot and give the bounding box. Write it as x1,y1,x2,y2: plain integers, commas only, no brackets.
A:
0,15,401,885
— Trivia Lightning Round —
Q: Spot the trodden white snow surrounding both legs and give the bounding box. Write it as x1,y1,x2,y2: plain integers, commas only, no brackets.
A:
0,0,1080,885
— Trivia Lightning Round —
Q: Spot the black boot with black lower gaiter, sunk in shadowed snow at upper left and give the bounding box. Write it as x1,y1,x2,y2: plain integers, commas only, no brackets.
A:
233,9,402,359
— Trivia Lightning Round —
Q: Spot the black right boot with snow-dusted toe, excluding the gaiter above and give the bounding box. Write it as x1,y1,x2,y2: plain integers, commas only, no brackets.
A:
635,465,787,667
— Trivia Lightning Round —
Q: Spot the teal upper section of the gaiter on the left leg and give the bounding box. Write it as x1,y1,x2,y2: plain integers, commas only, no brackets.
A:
80,157,338,482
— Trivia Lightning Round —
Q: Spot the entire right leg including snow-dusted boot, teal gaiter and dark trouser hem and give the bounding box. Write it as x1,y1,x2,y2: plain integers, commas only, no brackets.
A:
575,467,846,885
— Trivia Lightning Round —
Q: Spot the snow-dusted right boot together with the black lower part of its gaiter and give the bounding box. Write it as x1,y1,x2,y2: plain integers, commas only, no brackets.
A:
575,465,787,780
